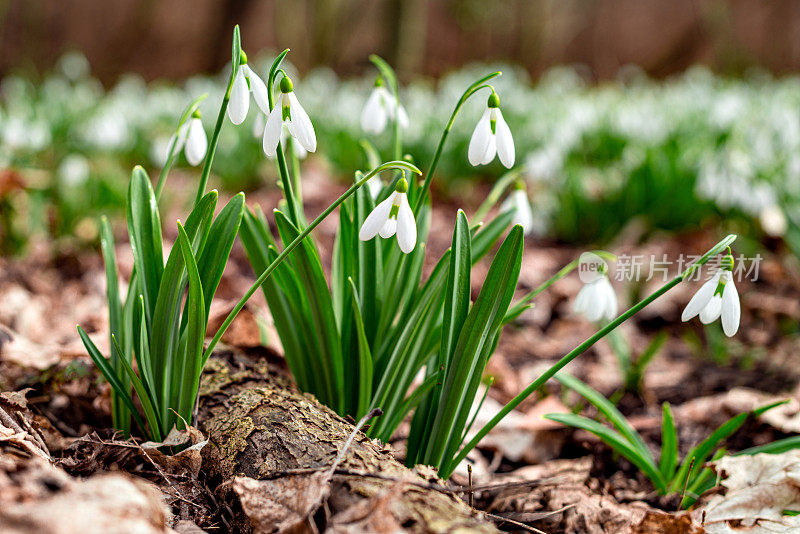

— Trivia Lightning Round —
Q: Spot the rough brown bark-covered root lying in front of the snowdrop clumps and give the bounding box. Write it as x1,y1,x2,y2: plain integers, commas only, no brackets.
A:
198,353,497,532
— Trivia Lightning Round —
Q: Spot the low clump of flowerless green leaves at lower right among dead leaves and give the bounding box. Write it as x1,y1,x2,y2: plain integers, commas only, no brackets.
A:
545,373,797,508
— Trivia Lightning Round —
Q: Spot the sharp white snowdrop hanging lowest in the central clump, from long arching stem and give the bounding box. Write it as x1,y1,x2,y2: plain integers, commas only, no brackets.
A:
358,178,417,254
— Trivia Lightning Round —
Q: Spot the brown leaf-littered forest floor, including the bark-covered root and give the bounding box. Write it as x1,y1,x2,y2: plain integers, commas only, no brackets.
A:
0,173,800,534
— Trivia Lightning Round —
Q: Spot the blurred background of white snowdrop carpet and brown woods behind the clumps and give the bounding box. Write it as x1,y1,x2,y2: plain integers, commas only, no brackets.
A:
0,0,800,253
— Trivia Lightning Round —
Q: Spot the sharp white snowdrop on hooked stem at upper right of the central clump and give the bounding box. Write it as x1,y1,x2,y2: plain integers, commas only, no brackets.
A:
467,91,514,169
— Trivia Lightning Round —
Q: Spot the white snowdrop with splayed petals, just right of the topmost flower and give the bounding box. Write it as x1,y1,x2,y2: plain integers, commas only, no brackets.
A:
263,76,317,158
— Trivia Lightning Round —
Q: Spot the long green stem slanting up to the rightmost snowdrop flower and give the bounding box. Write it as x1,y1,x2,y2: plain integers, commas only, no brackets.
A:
439,234,736,479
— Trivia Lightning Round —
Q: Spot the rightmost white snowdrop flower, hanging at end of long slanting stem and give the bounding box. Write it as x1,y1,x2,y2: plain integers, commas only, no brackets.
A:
681,254,742,337
